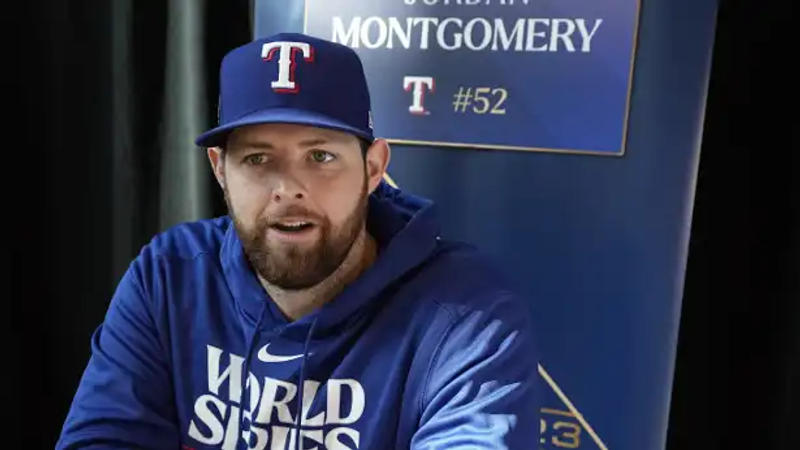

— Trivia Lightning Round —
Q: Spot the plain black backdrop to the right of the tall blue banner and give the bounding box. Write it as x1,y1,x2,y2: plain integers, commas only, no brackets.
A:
664,0,800,450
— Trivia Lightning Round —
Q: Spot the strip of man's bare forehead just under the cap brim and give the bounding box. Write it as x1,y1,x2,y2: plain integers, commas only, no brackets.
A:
228,123,358,148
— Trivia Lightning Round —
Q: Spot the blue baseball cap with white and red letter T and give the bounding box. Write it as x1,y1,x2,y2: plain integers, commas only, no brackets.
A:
195,33,375,147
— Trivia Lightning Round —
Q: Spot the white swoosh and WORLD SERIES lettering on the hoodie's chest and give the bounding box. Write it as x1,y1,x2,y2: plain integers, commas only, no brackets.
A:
189,345,366,450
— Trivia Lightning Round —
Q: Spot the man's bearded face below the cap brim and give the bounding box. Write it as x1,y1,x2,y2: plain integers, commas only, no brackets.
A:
209,124,377,289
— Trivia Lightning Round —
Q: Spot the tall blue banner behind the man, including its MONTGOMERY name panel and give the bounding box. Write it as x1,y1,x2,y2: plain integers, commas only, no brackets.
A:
255,0,717,450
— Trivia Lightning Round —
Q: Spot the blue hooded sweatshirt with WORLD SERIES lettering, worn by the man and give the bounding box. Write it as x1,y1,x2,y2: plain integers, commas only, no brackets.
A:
56,183,541,450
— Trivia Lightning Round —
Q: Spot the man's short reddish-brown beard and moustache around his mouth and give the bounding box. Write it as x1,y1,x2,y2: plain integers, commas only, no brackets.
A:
225,176,368,290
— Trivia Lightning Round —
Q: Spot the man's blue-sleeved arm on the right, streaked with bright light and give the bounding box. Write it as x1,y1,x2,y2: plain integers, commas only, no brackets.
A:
411,297,541,450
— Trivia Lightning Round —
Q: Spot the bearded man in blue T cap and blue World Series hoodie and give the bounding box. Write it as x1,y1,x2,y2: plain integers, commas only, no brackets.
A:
57,34,539,450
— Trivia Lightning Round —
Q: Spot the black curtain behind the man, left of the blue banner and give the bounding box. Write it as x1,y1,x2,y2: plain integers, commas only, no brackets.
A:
10,0,252,449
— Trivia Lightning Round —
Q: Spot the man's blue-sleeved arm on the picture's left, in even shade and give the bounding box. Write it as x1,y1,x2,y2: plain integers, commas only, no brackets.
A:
56,260,179,449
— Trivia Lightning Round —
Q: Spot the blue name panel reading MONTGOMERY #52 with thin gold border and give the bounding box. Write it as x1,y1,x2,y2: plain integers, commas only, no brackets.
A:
304,0,639,155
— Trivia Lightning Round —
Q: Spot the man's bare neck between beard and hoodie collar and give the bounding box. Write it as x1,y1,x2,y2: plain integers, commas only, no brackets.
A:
258,230,378,321
